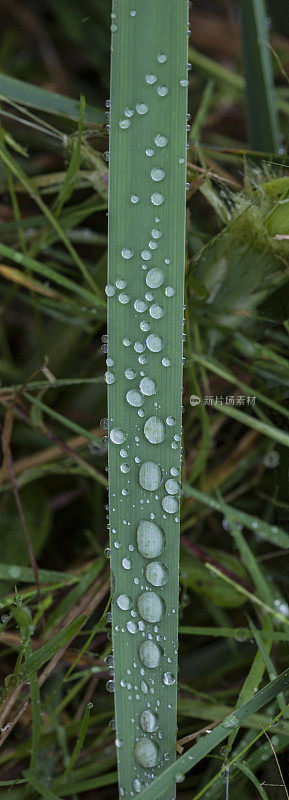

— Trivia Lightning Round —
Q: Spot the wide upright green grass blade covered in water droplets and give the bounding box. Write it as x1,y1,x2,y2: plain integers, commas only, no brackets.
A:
107,0,188,800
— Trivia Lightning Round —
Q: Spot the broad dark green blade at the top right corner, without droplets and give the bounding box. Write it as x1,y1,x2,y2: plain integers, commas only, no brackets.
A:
241,0,280,153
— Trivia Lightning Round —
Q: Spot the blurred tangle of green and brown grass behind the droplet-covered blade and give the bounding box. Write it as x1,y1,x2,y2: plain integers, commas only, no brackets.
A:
0,0,289,800
